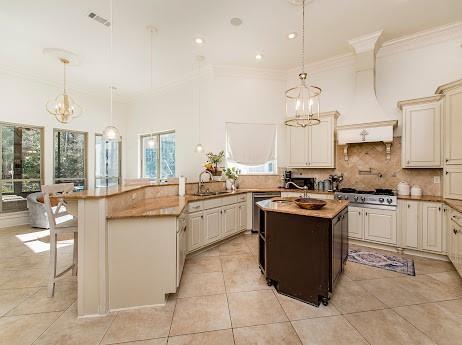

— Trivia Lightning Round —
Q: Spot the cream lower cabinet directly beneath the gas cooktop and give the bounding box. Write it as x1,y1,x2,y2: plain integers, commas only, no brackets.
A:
348,206,397,244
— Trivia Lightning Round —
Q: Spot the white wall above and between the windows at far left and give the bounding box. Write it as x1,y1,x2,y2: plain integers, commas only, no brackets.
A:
0,72,128,187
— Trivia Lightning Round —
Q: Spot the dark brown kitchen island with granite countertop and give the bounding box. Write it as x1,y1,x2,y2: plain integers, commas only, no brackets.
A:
257,198,348,306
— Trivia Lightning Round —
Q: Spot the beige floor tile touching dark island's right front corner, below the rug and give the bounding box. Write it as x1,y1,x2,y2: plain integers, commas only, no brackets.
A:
331,280,386,313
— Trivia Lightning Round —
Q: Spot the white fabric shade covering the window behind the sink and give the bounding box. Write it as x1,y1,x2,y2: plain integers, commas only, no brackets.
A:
226,122,277,166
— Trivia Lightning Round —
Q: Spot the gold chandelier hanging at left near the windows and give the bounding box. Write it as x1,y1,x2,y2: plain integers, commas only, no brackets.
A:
46,58,82,123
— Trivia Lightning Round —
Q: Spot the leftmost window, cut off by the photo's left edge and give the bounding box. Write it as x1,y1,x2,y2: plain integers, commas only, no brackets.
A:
0,123,43,212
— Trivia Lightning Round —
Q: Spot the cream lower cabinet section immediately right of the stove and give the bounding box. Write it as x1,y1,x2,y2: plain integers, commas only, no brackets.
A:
398,200,446,254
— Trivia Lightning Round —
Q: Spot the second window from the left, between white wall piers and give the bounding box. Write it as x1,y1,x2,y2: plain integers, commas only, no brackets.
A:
53,129,87,191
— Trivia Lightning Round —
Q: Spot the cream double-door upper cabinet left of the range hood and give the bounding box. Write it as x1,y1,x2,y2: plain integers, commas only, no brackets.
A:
287,112,339,168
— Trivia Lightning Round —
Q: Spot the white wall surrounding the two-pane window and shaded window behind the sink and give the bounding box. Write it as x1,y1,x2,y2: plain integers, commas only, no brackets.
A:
127,68,286,181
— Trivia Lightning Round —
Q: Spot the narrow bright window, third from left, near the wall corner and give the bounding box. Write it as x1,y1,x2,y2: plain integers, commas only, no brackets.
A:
95,134,122,187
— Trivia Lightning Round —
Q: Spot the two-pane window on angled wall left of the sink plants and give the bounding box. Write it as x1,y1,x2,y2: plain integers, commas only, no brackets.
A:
140,131,175,179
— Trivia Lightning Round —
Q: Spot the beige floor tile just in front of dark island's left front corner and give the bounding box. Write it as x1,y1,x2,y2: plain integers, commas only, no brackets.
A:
228,290,288,327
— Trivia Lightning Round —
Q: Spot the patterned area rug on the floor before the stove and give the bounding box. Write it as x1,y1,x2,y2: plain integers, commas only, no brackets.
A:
348,249,415,276
